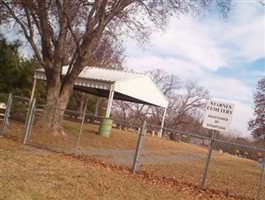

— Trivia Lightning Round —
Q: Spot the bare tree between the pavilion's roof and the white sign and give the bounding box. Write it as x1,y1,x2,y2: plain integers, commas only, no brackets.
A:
148,70,209,127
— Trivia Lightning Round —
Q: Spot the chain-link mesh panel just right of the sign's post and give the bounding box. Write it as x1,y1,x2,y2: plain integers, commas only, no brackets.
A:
207,140,264,199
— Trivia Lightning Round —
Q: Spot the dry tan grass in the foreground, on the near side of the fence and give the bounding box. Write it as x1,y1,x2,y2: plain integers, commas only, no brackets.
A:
0,138,196,200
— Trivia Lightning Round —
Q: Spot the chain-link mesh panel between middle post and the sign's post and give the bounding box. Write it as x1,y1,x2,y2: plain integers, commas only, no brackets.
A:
140,125,208,185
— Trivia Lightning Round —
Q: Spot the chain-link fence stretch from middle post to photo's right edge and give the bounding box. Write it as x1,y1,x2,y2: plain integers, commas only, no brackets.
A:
140,125,265,199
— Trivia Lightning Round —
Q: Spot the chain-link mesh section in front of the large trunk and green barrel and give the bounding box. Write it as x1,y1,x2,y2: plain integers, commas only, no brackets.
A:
28,106,138,166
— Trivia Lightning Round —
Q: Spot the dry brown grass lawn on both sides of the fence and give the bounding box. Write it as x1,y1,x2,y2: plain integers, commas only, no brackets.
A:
0,121,261,200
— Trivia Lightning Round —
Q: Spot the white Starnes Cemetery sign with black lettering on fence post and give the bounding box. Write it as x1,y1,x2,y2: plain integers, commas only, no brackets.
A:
202,100,235,132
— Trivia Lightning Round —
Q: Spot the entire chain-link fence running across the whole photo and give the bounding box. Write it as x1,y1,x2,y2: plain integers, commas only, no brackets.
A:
0,95,265,199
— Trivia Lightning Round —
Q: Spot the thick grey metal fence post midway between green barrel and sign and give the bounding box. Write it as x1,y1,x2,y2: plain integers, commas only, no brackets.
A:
132,121,146,174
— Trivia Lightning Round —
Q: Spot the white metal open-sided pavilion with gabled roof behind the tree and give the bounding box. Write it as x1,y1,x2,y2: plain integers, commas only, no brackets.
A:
31,66,168,136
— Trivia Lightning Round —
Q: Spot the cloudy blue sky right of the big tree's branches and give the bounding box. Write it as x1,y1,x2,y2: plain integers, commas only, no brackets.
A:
126,0,265,137
